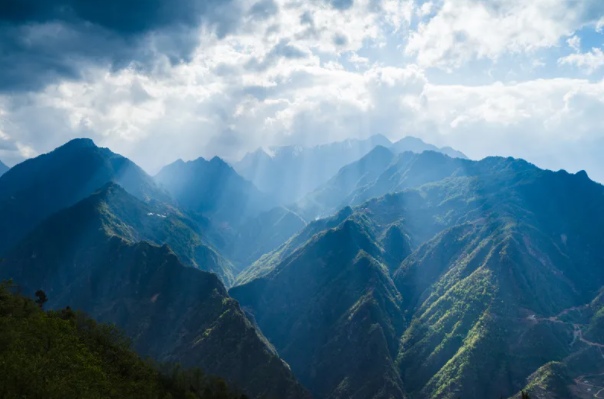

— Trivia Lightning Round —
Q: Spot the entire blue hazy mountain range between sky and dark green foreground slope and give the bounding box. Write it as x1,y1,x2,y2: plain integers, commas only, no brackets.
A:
0,136,604,399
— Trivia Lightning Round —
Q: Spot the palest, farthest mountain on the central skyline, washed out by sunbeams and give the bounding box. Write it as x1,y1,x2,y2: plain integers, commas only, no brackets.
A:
233,135,392,205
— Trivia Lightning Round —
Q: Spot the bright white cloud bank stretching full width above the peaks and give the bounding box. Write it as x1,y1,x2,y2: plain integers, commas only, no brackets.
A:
0,0,604,184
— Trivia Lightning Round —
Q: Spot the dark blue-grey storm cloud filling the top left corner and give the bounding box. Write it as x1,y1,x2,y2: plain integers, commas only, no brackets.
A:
0,0,242,92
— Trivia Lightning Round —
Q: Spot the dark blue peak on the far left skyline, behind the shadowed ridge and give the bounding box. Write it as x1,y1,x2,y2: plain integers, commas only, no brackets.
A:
0,139,171,253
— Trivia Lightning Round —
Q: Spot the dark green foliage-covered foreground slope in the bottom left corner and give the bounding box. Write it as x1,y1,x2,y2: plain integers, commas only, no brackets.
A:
0,283,241,399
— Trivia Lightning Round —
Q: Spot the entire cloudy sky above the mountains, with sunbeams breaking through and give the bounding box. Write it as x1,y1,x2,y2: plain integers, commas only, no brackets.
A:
0,0,604,182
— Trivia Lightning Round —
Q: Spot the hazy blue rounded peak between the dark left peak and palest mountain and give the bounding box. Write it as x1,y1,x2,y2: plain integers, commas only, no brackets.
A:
155,157,274,227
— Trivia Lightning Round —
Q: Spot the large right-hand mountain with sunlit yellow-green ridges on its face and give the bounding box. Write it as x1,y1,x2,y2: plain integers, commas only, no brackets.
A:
394,165,604,398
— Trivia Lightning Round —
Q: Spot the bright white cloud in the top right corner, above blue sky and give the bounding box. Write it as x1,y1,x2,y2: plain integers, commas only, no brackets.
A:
405,0,604,69
